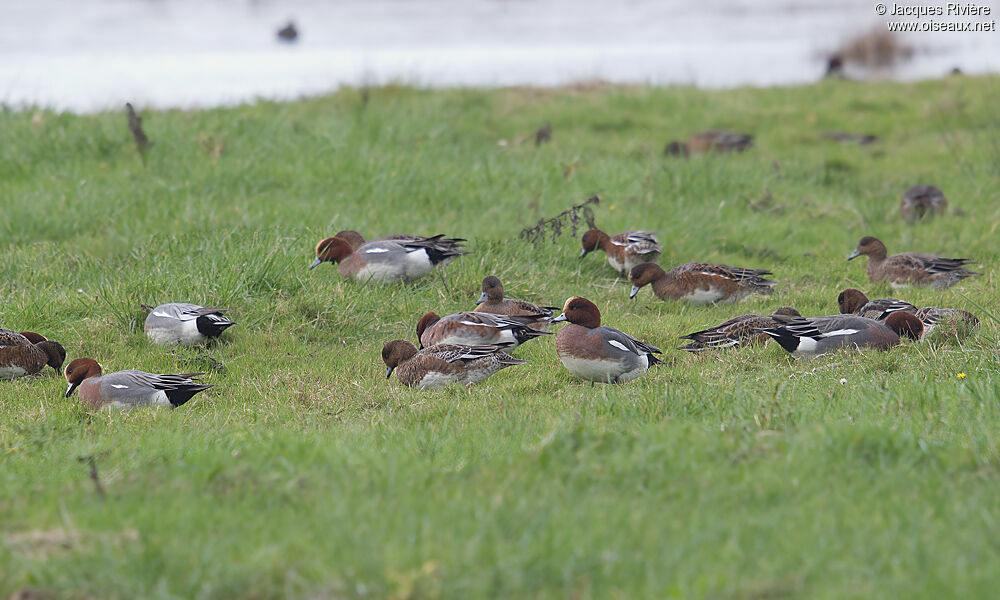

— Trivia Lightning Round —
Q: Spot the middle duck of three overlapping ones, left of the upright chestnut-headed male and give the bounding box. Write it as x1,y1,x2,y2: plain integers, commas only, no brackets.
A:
417,312,552,348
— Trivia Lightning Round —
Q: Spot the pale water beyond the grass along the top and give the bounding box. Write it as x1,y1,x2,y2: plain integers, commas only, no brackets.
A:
0,0,1000,112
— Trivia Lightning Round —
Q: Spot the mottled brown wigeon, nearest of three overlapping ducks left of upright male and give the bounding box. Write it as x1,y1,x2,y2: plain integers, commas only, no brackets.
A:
382,340,528,389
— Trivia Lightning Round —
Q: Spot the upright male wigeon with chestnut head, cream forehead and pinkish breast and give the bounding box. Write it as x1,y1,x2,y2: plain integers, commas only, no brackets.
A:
552,296,662,383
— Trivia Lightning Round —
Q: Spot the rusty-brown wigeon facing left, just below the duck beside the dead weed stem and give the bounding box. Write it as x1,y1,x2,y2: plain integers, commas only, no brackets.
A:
628,263,777,304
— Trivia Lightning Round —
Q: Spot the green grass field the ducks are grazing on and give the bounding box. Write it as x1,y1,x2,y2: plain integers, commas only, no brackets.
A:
0,77,1000,599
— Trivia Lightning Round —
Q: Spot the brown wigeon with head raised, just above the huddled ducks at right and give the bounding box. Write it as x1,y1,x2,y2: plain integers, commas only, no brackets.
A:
847,235,982,288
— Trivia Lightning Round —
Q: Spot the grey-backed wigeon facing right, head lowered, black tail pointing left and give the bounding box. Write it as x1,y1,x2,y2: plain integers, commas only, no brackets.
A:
762,311,924,358
